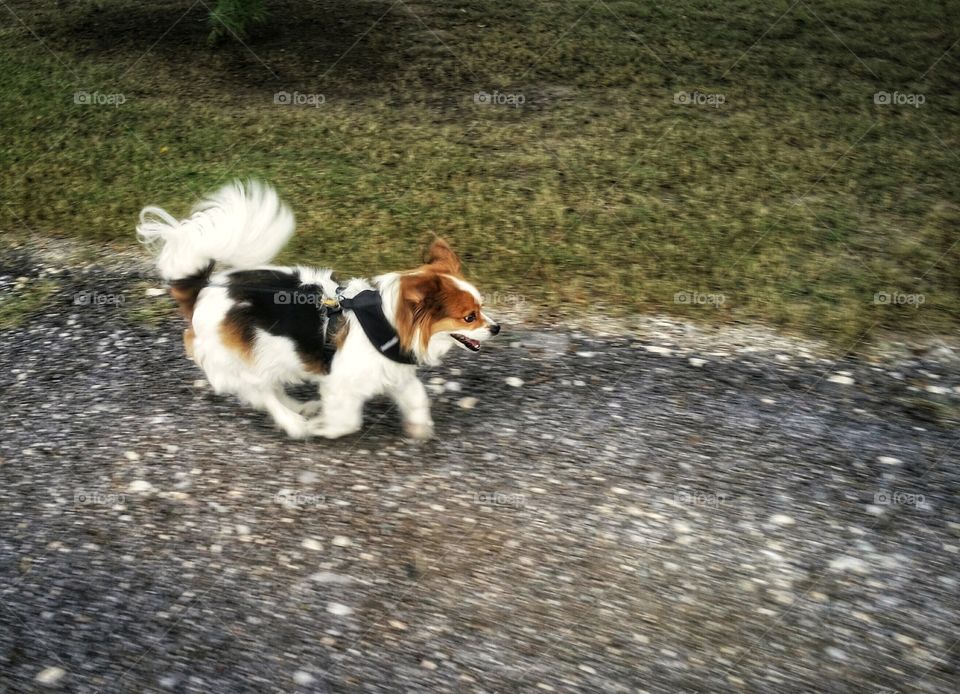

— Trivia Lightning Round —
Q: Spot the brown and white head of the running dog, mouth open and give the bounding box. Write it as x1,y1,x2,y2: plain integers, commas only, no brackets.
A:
396,239,500,364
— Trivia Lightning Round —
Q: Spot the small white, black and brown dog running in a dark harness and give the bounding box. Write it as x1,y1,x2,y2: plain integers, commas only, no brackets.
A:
137,181,500,439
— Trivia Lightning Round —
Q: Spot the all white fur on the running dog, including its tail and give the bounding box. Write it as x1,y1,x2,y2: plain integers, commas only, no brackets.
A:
143,182,502,438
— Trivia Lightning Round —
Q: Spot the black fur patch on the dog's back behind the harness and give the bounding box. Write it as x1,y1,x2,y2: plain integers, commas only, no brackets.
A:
226,270,336,372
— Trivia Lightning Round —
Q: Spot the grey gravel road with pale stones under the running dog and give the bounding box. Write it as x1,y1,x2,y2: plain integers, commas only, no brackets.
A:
0,255,960,694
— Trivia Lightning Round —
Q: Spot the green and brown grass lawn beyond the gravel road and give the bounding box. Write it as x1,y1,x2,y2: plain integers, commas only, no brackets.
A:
0,0,960,349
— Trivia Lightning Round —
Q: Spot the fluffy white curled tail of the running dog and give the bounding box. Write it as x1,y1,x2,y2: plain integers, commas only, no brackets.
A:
137,181,294,281
